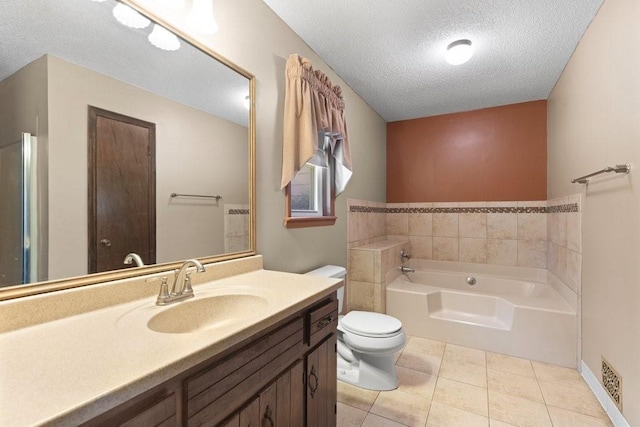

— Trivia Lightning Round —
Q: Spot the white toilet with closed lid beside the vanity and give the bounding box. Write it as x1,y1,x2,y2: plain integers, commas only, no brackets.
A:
307,265,407,390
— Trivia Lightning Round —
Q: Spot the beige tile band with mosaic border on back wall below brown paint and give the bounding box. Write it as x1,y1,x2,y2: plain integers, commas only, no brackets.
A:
372,201,547,268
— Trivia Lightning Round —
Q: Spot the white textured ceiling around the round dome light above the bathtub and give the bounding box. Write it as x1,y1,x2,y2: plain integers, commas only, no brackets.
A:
263,0,602,121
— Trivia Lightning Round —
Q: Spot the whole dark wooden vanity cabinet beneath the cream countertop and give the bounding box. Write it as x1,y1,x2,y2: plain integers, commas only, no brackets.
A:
88,293,338,427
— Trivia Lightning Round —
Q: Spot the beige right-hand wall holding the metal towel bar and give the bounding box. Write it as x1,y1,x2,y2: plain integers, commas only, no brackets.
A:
548,0,640,425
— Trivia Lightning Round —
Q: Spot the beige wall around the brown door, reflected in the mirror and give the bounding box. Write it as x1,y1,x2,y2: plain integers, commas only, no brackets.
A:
48,56,248,279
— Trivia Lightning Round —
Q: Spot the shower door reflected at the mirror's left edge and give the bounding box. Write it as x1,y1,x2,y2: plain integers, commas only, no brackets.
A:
0,133,44,286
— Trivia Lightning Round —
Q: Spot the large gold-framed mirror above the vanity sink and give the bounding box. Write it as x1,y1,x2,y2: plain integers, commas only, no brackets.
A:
0,0,255,299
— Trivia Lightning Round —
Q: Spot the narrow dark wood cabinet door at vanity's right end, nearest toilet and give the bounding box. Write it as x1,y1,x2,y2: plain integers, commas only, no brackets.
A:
306,334,338,427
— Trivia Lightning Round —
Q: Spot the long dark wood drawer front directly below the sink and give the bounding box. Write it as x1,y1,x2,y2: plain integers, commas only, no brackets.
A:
186,317,304,425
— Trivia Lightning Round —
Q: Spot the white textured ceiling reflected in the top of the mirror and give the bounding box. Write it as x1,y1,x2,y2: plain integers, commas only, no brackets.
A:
0,0,249,126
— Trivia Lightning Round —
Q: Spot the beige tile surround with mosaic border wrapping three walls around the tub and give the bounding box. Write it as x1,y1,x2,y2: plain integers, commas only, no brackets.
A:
347,198,582,348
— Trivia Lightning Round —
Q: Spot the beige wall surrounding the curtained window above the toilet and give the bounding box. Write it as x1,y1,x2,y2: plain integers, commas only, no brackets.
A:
141,0,386,272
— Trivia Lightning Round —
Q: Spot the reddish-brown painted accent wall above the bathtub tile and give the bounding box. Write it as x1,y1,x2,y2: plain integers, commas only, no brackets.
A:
387,100,547,203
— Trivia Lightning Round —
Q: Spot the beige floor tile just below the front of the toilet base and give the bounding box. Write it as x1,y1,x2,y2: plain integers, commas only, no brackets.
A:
370,390,430,426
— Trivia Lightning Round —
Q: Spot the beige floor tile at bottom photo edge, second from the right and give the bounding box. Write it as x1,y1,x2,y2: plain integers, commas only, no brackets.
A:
489,390,552,427
